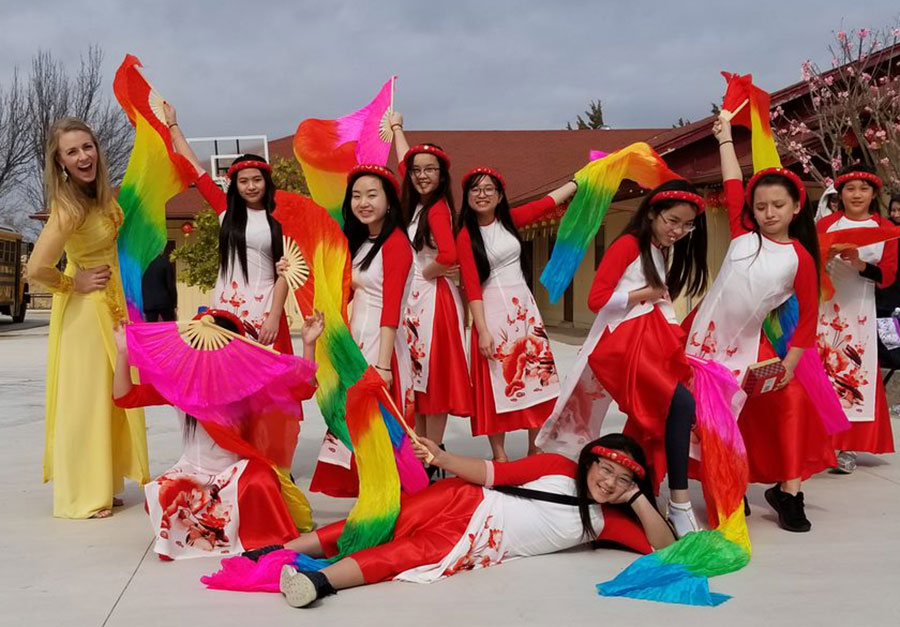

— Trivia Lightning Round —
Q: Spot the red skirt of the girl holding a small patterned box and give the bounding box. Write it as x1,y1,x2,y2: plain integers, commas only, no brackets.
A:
738,334,837,483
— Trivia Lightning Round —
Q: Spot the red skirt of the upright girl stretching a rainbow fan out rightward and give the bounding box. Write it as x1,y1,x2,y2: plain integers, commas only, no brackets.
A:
469,327,556,435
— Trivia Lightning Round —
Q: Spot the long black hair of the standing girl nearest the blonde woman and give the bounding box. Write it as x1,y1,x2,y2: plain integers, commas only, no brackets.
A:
219,153,284,281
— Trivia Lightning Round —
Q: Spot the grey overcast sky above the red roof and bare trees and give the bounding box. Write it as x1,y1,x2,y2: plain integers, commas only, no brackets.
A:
0,0,900,138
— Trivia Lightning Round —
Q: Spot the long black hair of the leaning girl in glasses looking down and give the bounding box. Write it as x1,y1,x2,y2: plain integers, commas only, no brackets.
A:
622,179,709,299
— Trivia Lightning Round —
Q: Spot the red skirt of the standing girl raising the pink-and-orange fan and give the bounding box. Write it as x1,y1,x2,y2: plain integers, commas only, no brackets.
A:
416,280,472,416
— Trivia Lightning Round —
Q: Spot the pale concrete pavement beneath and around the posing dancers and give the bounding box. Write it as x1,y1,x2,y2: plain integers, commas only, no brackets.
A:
0,312,900,627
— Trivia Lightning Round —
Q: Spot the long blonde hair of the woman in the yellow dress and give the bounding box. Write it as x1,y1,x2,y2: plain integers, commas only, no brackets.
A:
44,117,113,226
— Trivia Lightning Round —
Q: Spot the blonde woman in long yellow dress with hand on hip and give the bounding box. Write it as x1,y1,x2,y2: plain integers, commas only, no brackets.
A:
28,118,150,518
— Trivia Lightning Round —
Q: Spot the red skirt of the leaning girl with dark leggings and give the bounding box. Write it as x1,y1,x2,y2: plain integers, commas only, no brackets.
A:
588,308,692,489
